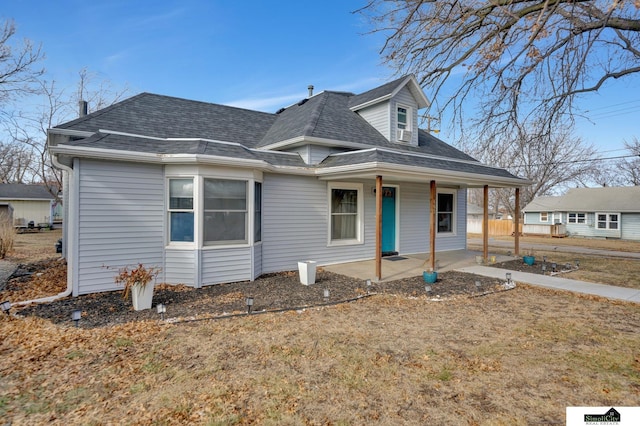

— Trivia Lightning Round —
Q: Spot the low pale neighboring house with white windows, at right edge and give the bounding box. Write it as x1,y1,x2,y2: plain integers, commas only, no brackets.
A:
522,186,640,240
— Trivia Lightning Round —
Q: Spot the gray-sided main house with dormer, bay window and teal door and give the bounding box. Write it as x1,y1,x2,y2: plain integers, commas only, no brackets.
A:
48,76,529,295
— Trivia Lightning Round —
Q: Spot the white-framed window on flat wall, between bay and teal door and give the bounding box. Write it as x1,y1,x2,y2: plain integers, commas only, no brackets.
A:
329,184,363,243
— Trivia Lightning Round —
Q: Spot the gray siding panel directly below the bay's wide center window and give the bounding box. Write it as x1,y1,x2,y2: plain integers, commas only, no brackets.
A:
201,247,252,285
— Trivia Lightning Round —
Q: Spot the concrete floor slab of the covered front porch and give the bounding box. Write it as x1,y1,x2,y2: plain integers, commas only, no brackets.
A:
323,250,513,282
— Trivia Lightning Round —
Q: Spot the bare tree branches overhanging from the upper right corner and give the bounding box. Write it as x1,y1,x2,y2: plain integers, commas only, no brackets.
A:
358,0,640,138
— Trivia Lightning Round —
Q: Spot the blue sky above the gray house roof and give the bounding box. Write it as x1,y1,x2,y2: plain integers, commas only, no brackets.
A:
0,0,640,156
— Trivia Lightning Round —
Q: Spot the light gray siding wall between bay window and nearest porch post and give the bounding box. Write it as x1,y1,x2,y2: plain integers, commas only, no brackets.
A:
262,174,375,273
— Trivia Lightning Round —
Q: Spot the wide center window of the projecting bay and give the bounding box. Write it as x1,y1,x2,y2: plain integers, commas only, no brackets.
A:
203,179,247,244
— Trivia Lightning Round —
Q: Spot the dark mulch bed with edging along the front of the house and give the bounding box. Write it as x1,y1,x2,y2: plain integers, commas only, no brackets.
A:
10,262,504,328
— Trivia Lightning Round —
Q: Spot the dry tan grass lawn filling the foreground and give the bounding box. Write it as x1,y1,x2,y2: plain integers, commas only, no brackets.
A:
0,230,640,425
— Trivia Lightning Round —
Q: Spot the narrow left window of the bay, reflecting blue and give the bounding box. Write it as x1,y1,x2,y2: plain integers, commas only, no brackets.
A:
169,179,193,242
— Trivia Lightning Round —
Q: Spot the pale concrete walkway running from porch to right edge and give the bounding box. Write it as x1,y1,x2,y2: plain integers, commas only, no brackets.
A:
457,265,640,303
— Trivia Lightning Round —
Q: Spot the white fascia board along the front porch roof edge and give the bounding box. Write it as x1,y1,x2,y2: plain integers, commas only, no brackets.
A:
316,162,529,187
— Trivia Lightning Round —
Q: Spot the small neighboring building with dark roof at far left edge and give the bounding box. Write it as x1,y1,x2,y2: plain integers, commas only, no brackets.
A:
0,183,54,226
